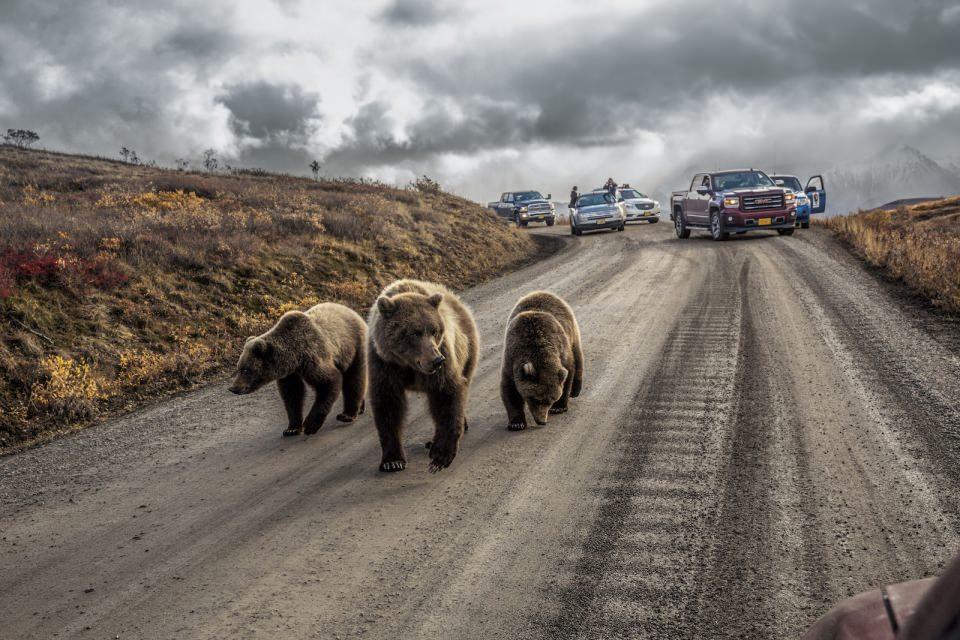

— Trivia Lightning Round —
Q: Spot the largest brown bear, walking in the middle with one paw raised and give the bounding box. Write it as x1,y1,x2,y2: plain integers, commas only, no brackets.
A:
367,280,480,473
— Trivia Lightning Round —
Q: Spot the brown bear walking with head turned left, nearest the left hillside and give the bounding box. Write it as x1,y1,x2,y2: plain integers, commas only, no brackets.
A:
230,302,367,436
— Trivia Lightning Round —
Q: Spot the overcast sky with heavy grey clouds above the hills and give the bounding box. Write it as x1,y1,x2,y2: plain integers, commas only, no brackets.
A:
0,0,960,201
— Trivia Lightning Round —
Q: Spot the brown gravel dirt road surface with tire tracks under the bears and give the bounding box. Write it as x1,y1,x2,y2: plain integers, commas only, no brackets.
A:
0,224,960,639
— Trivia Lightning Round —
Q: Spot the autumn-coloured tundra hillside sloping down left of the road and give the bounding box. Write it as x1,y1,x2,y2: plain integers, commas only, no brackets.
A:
0,146,535,450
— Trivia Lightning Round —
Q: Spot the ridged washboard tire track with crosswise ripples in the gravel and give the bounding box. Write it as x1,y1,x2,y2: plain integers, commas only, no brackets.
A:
540,248,741,639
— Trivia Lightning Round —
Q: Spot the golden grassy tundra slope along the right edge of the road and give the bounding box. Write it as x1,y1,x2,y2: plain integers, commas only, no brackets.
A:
823,197,960,312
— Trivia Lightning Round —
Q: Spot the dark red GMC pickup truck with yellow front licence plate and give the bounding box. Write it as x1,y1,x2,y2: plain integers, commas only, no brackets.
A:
670,169,797,240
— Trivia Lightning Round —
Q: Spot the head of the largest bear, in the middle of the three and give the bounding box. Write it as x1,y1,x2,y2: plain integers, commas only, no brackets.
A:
374,293,446,376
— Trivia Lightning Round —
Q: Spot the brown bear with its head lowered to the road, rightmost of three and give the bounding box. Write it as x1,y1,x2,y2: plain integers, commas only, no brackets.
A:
500,291,583,431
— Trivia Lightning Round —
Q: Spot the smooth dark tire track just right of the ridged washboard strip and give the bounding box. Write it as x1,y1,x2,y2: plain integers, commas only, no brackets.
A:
695,254,829,640
